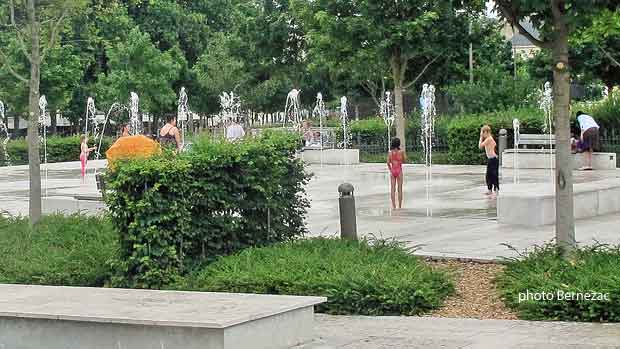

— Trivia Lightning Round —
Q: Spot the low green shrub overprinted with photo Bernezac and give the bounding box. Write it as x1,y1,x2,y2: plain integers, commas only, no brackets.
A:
498,244,620,322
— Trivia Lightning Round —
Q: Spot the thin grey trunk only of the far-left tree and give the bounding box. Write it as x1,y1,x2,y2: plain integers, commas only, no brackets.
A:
27,0,41,224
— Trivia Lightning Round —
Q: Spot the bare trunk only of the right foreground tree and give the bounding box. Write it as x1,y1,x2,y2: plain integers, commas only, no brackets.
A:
553,19,575,252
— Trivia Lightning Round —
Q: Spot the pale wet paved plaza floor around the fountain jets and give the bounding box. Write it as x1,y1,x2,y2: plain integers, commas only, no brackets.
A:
0,161,620,260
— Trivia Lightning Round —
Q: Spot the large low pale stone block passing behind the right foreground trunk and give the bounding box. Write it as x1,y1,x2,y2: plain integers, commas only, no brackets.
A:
497,178,620,226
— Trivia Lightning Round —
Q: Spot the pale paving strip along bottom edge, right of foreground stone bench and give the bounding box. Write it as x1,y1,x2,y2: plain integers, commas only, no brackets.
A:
295,314,620,349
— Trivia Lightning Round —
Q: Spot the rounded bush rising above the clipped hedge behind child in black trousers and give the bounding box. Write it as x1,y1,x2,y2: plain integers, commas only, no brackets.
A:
446,65,541,113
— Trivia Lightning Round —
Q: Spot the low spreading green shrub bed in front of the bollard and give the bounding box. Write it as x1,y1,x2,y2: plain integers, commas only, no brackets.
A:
176,238,454,315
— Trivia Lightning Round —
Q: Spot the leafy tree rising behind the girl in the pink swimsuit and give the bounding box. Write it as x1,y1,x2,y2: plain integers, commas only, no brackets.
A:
299,0,474,145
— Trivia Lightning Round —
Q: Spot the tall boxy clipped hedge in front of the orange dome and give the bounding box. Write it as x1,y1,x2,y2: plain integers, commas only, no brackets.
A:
107,132,309,288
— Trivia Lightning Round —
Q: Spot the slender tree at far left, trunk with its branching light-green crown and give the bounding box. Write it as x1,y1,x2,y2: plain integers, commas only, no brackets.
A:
0,0,81,224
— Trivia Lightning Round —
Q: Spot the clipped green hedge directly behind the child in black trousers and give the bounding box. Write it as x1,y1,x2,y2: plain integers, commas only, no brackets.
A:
447,109,544,165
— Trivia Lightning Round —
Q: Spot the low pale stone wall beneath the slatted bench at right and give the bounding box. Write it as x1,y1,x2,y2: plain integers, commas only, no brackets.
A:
502,149,616,170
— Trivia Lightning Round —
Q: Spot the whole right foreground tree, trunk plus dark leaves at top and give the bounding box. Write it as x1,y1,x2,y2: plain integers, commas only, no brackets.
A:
495,0,618,253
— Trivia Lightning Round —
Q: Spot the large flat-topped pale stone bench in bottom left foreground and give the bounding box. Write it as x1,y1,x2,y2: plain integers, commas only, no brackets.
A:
0,285,326,349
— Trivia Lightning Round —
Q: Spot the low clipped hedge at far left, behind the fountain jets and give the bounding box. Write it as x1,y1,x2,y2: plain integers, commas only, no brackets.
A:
0,136,113,165
